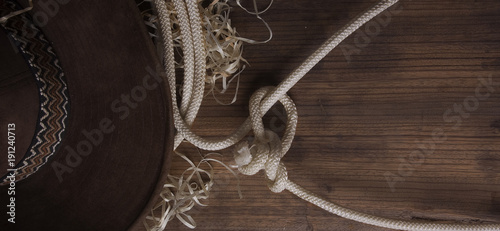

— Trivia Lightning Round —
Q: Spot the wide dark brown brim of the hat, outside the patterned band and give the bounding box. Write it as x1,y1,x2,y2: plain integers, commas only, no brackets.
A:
0,0,173,230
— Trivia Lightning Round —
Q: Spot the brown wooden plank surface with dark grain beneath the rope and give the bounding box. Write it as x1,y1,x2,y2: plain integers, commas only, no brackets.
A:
168,0,500,231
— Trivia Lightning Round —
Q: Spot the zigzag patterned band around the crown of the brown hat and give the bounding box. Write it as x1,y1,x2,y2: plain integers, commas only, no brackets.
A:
0,0,69,185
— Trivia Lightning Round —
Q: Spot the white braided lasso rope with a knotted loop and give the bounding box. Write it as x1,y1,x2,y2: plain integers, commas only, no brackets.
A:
154,0,500,231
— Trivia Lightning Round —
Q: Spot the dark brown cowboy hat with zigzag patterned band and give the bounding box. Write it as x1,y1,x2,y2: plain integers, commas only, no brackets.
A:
0,0,173,230
